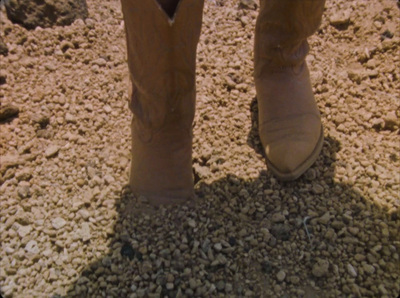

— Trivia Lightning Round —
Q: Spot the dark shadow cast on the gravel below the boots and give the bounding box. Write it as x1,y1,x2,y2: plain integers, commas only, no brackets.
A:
61,101,400,297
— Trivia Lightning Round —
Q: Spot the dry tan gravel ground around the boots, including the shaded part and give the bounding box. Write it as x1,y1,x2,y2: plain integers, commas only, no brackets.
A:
0,0,400,297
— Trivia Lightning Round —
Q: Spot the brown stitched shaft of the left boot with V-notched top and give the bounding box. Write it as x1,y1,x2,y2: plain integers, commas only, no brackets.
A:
121,0,203,129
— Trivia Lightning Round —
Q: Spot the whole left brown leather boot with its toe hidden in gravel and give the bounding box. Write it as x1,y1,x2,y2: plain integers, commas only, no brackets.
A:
121,0,203,205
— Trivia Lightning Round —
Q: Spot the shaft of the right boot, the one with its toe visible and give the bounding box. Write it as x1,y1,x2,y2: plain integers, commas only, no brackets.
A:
254,0,325,77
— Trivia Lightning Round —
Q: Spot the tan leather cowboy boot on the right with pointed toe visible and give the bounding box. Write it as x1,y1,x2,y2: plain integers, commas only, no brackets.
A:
254,0,325,180
